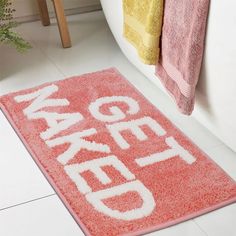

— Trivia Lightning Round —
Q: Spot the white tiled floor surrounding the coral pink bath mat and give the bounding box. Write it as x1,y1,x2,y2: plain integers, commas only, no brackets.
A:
0,12,236,236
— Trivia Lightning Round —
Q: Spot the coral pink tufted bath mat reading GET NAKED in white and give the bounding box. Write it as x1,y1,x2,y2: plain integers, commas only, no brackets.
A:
0,68,236,236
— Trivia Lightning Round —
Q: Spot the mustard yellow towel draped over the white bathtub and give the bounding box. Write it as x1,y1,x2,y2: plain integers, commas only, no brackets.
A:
123,0,164,65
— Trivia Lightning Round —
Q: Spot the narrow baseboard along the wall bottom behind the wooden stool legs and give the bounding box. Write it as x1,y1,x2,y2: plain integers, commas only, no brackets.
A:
14,4,102,23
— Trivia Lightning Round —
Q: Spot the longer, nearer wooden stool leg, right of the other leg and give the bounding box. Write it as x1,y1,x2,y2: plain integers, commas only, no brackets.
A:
52,0,71,48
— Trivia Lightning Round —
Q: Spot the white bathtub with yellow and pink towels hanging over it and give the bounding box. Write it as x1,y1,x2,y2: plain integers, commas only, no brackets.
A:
101,0,236,151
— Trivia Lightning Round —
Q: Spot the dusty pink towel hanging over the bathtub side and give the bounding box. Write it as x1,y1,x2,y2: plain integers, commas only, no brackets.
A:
156,0,210,115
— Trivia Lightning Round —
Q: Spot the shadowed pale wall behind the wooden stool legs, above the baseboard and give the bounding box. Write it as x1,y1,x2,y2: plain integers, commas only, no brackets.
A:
12,0,100,21
